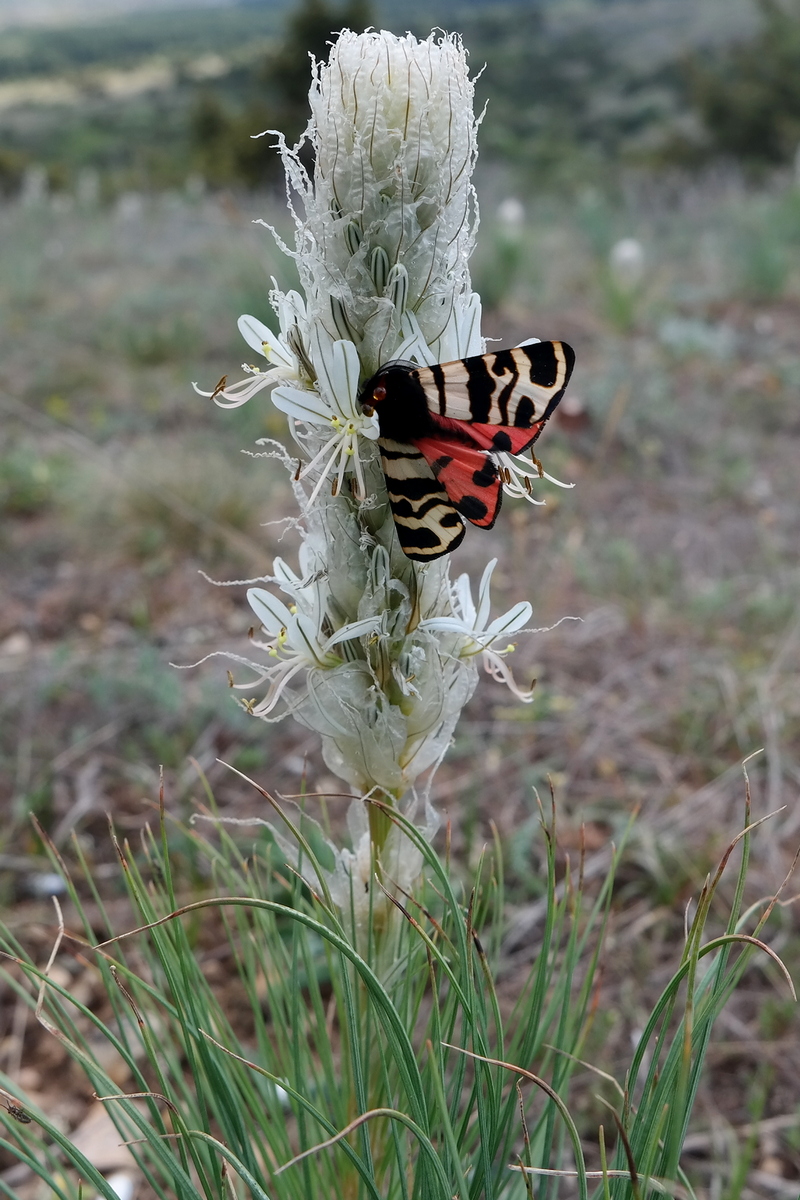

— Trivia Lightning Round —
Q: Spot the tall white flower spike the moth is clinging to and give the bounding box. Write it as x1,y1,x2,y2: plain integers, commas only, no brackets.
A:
196,31,554,916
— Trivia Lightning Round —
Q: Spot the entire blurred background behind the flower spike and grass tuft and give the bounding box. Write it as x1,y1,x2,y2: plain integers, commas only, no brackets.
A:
0,0,800,1180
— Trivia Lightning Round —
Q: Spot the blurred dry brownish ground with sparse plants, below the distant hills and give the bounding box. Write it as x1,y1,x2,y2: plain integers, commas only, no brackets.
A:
0,180,800,1196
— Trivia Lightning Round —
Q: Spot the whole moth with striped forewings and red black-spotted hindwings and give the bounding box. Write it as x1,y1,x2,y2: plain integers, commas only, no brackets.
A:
359,342,575,563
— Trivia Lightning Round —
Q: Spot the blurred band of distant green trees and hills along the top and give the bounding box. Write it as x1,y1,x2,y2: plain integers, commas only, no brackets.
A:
0,0,800,192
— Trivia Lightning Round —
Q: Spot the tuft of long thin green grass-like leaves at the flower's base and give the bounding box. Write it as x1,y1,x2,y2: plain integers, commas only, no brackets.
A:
0,772,786,1200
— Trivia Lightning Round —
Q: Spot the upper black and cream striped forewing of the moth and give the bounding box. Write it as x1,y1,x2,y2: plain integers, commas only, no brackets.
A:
415,342,575,430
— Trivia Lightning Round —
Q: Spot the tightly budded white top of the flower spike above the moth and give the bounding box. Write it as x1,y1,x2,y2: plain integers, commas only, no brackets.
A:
268,30,480,376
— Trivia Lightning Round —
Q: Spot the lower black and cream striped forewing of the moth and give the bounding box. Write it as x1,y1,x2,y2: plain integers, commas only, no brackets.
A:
378,438,464,563
